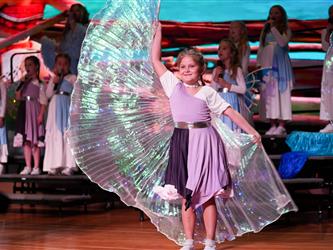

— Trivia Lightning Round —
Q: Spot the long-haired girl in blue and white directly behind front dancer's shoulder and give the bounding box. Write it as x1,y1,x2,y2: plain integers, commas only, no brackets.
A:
212,39,249,132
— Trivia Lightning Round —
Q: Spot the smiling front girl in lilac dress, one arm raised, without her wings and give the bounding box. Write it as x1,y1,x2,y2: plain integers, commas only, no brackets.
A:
152,25,260,250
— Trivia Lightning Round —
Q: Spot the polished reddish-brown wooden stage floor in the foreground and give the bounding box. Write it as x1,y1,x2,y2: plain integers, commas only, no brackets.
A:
0,208,333,250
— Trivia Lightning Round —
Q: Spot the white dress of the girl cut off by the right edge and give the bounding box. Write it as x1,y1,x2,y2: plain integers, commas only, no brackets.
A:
320,29,333,121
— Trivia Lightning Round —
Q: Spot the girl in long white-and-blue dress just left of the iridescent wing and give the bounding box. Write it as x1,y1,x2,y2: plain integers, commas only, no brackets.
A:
43,54,76,175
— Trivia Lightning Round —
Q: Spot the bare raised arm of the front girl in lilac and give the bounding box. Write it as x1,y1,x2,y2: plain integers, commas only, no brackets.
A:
151,23,167,77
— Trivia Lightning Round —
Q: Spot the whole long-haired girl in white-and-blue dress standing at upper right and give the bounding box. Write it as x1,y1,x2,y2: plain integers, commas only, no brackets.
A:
257,5,293,135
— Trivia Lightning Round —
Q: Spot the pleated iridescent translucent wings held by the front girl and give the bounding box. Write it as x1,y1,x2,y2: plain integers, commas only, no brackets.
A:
68,0,297,244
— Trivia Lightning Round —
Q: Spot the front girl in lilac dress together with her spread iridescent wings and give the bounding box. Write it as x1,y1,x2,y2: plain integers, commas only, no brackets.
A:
68,0,297,249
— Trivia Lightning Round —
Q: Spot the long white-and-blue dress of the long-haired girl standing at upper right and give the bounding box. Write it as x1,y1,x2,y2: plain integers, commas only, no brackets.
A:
257,27,294,120
